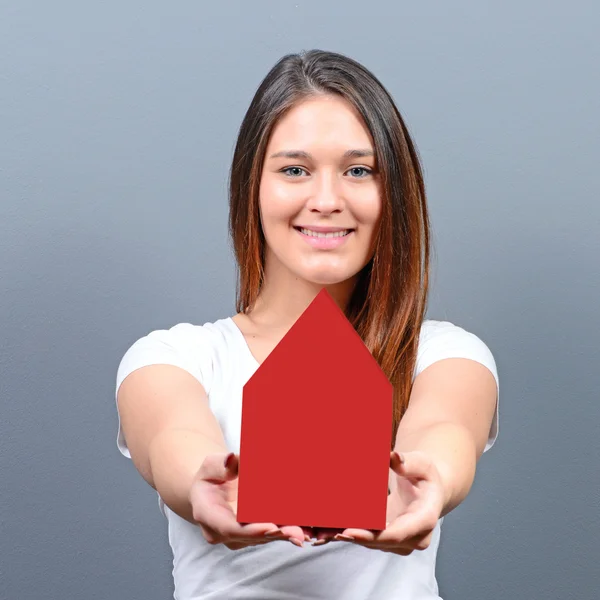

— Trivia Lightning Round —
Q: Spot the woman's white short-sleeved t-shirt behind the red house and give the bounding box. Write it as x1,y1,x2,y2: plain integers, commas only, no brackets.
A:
115,318,499,600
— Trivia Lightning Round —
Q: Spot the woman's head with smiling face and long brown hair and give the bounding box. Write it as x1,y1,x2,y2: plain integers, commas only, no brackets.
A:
230,55,430,430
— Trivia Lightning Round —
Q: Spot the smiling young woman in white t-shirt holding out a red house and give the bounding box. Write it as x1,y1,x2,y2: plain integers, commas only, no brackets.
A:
116,50,498,600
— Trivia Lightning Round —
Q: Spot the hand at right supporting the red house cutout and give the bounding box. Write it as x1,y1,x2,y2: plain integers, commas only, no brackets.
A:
315,451,445,556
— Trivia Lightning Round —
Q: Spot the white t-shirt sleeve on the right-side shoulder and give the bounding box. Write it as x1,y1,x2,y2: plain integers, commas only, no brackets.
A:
414,321,500,452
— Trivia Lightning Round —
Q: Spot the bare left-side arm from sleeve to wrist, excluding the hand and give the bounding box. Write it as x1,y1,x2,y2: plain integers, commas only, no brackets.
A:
117,365,227,523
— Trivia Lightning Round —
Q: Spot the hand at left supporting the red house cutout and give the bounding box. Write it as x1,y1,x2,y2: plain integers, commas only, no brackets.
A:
188,453,312,550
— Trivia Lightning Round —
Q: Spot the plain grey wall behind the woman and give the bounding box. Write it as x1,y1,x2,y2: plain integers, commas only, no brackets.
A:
0,0,600,600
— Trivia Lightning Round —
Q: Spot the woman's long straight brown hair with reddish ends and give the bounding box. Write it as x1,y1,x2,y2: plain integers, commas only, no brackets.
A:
229,50,431,446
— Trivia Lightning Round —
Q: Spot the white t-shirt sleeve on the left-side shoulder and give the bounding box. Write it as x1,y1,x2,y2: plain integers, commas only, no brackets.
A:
115,323,213,458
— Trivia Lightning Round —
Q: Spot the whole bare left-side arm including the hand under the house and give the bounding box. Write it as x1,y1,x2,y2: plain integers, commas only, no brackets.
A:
117,365,306,550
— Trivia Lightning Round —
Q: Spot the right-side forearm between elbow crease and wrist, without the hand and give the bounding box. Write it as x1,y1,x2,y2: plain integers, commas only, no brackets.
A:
395,423,477,516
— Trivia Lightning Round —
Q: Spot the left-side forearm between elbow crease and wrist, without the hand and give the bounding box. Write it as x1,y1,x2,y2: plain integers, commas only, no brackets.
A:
148,429,227,523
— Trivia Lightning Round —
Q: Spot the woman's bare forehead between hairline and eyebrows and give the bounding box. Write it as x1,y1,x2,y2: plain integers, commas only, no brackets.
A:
268,96,373,151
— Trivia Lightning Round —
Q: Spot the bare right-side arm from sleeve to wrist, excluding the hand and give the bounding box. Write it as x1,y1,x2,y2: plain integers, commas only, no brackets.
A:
394,358,497,516
